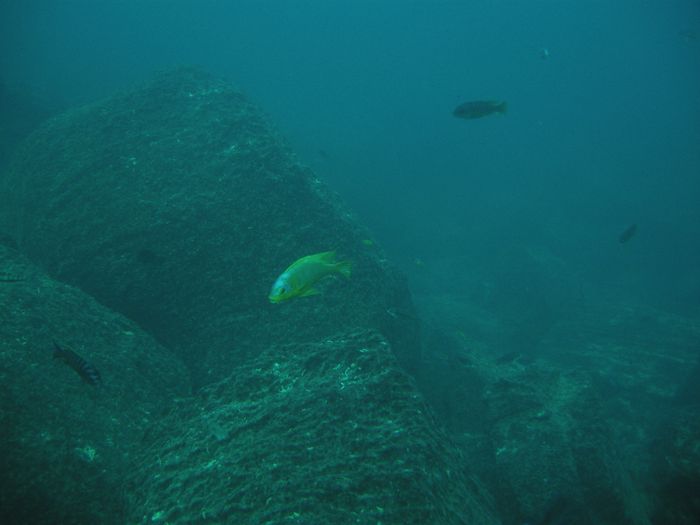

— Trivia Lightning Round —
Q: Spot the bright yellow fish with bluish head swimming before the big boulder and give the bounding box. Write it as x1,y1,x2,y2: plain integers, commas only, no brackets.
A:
268,252,350,303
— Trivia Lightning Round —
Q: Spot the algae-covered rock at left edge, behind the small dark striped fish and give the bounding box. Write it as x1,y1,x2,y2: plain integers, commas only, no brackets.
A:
0,245,190,524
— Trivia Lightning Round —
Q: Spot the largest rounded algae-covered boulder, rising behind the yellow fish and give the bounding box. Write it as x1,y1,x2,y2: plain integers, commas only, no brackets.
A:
0,69,419,384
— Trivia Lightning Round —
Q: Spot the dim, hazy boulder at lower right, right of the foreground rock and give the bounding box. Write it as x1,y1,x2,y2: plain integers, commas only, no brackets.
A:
474,361,645,525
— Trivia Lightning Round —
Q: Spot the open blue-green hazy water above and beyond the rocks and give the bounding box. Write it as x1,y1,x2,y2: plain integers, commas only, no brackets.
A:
0,0,700,307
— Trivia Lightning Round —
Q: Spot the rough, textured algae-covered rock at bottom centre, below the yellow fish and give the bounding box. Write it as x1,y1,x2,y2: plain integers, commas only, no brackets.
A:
129,331,497,525
